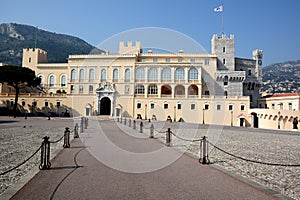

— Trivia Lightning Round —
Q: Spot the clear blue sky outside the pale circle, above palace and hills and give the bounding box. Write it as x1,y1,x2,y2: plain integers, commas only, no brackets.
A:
0,0,300,66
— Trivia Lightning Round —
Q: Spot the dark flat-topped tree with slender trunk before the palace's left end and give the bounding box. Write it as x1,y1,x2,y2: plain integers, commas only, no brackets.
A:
0,65,41,117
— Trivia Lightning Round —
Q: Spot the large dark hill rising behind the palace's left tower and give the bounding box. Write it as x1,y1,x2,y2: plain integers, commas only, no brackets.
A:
0,23,103,66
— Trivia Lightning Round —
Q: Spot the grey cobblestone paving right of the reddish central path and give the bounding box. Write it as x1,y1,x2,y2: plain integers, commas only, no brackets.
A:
145,122,300,199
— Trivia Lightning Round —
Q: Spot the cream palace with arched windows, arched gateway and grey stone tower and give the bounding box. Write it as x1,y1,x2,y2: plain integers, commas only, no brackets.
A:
1,34,263,126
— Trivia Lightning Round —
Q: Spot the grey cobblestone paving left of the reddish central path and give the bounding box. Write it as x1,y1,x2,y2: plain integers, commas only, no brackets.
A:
0,117,73,194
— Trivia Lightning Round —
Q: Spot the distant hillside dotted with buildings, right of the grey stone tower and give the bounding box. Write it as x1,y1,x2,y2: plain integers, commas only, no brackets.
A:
261,60,300,93
